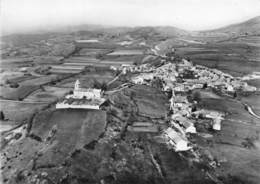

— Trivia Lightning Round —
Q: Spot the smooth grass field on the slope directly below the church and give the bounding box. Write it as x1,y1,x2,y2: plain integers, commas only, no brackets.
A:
31,109,106,165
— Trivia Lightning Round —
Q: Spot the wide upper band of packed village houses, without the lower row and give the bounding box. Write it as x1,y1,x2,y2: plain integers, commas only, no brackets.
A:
132,59,257,92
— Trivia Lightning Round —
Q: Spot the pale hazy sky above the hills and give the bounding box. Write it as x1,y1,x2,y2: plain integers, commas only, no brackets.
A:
1,0,260,32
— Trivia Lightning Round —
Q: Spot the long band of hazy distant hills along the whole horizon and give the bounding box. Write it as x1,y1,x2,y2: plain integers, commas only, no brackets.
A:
1,16,260,46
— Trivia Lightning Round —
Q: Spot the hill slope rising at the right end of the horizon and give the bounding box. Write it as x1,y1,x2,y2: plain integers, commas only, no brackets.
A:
200,16,260,36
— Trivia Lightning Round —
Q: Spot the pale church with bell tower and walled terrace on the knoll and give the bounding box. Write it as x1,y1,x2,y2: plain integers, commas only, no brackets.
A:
56,80,105,109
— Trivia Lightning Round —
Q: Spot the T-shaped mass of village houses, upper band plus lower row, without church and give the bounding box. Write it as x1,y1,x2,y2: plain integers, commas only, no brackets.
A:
129,59,256,151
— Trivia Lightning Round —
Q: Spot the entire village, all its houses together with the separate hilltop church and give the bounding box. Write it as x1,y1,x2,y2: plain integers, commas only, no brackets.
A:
53,46,257,153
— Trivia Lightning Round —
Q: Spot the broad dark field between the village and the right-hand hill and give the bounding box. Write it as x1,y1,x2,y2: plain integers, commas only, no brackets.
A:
176,37,260,76
